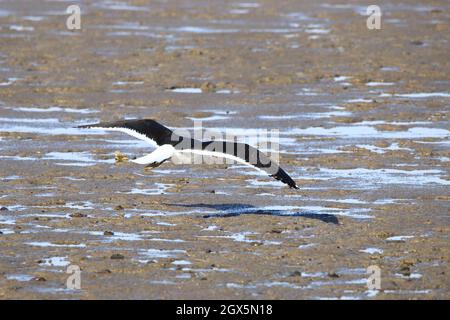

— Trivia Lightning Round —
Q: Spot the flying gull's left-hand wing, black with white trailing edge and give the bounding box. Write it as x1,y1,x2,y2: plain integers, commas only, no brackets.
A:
78,119,178,146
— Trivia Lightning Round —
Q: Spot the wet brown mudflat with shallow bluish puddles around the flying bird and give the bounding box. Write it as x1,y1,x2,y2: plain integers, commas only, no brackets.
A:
0,0,450,299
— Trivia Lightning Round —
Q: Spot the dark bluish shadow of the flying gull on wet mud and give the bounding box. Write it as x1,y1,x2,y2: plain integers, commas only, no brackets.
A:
166,203,339,224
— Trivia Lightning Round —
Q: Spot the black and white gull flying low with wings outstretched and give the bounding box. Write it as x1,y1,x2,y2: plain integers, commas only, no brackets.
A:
78,119,298,189
